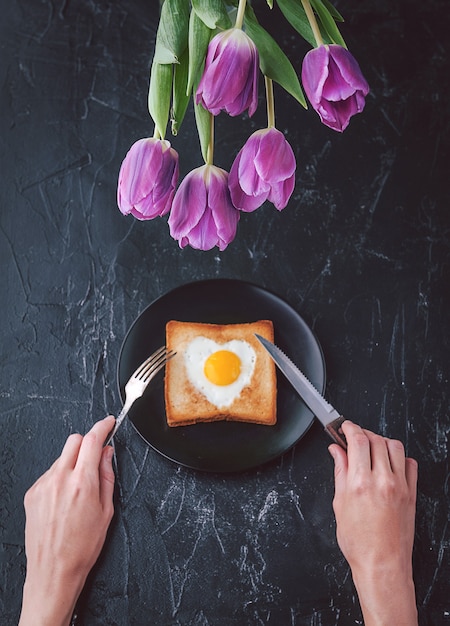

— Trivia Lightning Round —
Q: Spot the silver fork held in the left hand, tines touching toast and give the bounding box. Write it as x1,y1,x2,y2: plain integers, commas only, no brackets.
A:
103,346,176,446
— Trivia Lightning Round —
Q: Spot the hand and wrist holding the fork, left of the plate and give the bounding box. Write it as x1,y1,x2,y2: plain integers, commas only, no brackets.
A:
19,416,114,626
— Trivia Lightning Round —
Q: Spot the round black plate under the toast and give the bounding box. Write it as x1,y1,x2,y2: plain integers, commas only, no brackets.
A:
118,279,325,472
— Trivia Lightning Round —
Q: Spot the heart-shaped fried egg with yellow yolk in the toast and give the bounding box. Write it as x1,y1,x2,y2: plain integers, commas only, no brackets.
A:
184,336,256,409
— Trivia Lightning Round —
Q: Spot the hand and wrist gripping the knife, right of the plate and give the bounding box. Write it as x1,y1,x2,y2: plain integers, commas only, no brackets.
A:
329,421,417,626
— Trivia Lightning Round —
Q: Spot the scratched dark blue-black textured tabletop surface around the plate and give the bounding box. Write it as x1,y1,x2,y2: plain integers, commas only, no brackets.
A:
0,0,450,626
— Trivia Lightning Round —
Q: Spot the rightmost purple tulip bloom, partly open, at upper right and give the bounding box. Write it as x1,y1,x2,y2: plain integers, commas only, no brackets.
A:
302,44,369,132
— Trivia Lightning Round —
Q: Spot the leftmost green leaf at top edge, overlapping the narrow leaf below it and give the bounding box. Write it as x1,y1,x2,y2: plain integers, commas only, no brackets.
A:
154,0,189,64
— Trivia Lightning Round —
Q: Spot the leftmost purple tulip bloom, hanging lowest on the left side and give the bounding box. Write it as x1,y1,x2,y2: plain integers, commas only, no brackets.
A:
117,138,178,220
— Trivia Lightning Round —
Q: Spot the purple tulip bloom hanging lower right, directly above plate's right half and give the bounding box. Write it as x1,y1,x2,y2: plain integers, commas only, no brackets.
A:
229,128,296,212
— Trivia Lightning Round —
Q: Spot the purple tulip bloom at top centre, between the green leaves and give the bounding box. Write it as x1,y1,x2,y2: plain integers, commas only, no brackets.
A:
196,28,259,116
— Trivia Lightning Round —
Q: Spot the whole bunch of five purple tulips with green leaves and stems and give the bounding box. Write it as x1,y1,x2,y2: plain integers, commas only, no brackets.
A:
117,0,369,250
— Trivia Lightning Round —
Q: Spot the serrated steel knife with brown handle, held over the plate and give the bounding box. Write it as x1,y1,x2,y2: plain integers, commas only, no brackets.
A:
255,333,347,450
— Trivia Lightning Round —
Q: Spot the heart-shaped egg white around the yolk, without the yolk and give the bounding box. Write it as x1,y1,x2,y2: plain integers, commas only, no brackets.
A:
184,336,256,409
